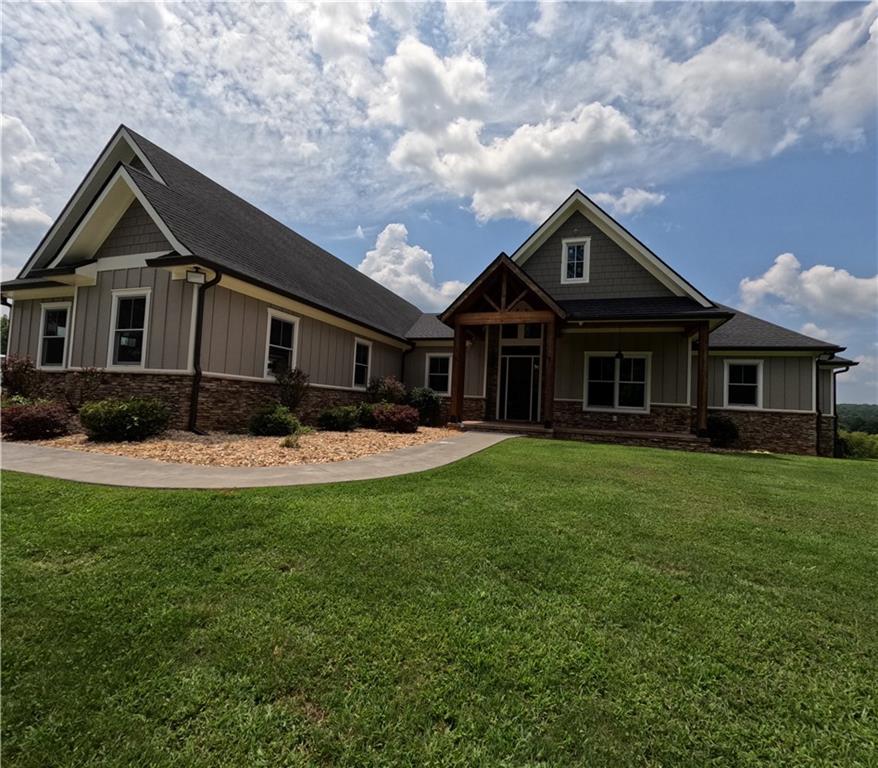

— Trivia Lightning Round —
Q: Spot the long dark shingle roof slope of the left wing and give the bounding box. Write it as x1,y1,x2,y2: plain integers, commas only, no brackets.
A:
129,129,422,338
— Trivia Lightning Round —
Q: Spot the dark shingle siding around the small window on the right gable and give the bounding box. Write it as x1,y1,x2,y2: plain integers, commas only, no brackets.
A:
522,212,673,299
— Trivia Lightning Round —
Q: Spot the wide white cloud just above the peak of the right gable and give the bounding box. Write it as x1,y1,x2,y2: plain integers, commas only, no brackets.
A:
390,103,637,222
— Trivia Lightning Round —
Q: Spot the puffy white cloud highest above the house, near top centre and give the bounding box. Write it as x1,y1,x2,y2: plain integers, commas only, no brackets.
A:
369,37,487,132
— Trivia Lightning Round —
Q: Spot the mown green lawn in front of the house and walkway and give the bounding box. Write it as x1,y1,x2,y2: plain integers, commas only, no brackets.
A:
2,440,878,768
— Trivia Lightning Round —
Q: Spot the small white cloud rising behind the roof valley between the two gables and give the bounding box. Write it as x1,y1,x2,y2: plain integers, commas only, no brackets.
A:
357,224,466,310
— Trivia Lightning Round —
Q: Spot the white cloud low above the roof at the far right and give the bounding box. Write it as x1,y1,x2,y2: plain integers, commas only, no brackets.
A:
740,253,878,321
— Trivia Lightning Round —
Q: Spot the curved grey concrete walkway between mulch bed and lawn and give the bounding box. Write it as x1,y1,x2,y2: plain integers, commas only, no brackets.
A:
0,432,514,488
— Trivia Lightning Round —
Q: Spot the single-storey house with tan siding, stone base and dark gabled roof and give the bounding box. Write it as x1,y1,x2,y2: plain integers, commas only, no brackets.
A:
2,126,853,455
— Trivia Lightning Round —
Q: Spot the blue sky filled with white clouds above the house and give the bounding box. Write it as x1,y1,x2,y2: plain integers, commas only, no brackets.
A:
0,3,878,402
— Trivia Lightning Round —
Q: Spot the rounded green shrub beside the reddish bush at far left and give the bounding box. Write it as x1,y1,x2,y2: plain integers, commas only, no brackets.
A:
79,397,171,442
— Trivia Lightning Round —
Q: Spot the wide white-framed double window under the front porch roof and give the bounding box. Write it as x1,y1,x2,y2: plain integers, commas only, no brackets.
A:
584,353,649,411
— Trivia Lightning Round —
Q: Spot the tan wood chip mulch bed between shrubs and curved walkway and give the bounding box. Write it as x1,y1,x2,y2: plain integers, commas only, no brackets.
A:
25,427,460,467
